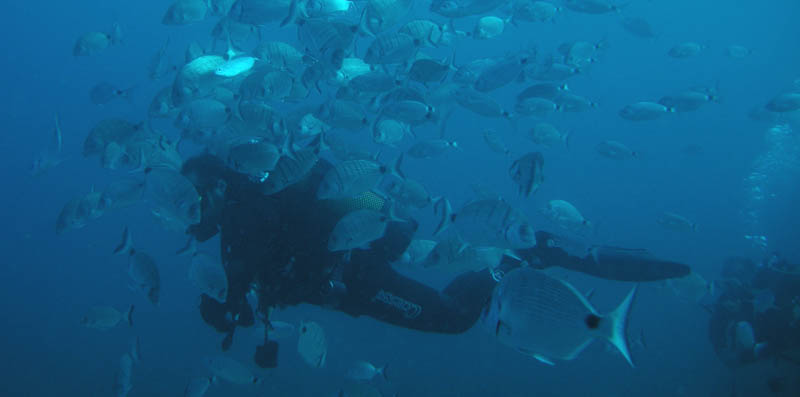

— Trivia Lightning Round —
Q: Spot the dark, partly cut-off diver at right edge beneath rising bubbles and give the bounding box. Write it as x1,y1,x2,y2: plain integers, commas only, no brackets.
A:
708,254,800,368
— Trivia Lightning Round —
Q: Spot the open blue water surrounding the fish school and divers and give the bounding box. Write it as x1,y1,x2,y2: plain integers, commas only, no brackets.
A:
0,0,800,396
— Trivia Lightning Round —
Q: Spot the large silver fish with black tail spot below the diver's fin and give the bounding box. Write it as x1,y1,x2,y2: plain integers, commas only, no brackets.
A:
481,267,636,366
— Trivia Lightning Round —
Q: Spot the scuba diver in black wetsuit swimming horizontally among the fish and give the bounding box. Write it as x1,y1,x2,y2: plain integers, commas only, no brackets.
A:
182,154,689,368
